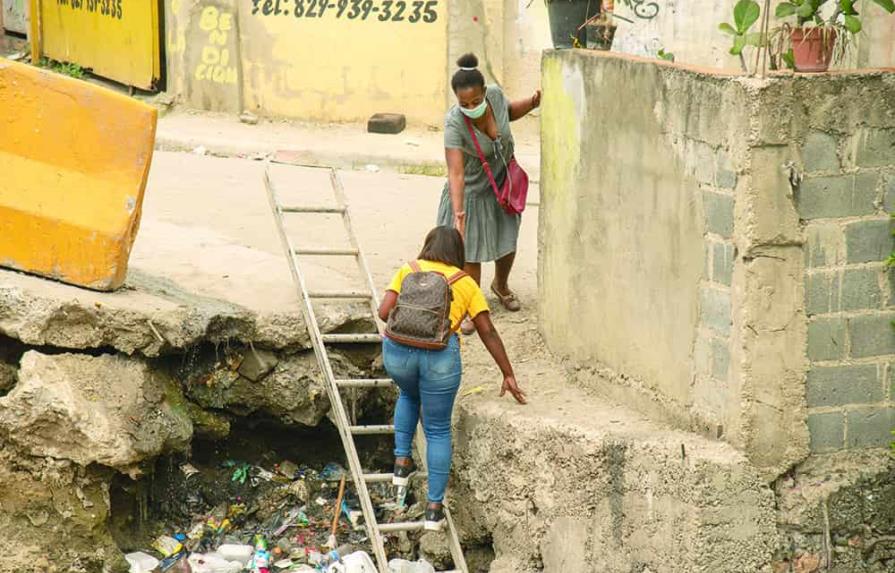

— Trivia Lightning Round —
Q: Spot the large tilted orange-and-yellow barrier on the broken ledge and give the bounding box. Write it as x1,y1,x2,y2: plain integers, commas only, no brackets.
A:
0,58,157,290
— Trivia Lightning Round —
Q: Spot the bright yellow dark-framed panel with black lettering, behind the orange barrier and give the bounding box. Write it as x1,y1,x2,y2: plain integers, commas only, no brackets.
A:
40,0,161,89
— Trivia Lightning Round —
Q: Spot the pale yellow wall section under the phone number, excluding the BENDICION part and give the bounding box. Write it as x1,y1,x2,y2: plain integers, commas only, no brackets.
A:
239,0,448,125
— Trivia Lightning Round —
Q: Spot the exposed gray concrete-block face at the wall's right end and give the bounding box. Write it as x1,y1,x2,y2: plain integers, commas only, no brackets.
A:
791,82,895,452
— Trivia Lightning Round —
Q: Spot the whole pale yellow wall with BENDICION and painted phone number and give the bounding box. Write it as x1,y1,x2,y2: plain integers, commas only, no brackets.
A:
167,0,447,125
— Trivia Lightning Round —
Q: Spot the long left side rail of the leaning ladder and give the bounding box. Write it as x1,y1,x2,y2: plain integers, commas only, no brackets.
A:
264,162,388,573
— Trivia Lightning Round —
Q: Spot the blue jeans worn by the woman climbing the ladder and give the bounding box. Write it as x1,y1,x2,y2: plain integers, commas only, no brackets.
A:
382,335,463,503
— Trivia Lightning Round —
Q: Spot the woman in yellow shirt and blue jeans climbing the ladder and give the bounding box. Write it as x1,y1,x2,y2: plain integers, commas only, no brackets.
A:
379,227,525,531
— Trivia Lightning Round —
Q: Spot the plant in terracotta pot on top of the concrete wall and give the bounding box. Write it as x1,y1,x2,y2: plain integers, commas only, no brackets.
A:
776,0,895,72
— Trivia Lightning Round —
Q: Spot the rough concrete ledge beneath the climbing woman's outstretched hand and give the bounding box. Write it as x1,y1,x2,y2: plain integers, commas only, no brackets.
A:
452,387,776,573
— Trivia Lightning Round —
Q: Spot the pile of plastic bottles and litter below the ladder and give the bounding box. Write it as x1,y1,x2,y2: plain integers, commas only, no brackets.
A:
125,460,434,573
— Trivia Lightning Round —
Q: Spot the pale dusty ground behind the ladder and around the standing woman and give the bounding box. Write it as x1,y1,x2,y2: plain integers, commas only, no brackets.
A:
140,152,540,384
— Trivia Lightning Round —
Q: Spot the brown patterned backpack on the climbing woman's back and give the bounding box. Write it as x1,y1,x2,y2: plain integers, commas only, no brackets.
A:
385,261,467,350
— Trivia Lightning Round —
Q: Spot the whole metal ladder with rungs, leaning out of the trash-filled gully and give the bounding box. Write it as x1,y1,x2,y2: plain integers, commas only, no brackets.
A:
264,160,469,573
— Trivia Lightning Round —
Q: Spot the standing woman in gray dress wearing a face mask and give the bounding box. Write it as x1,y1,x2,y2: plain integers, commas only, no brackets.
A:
438,54,541,334
